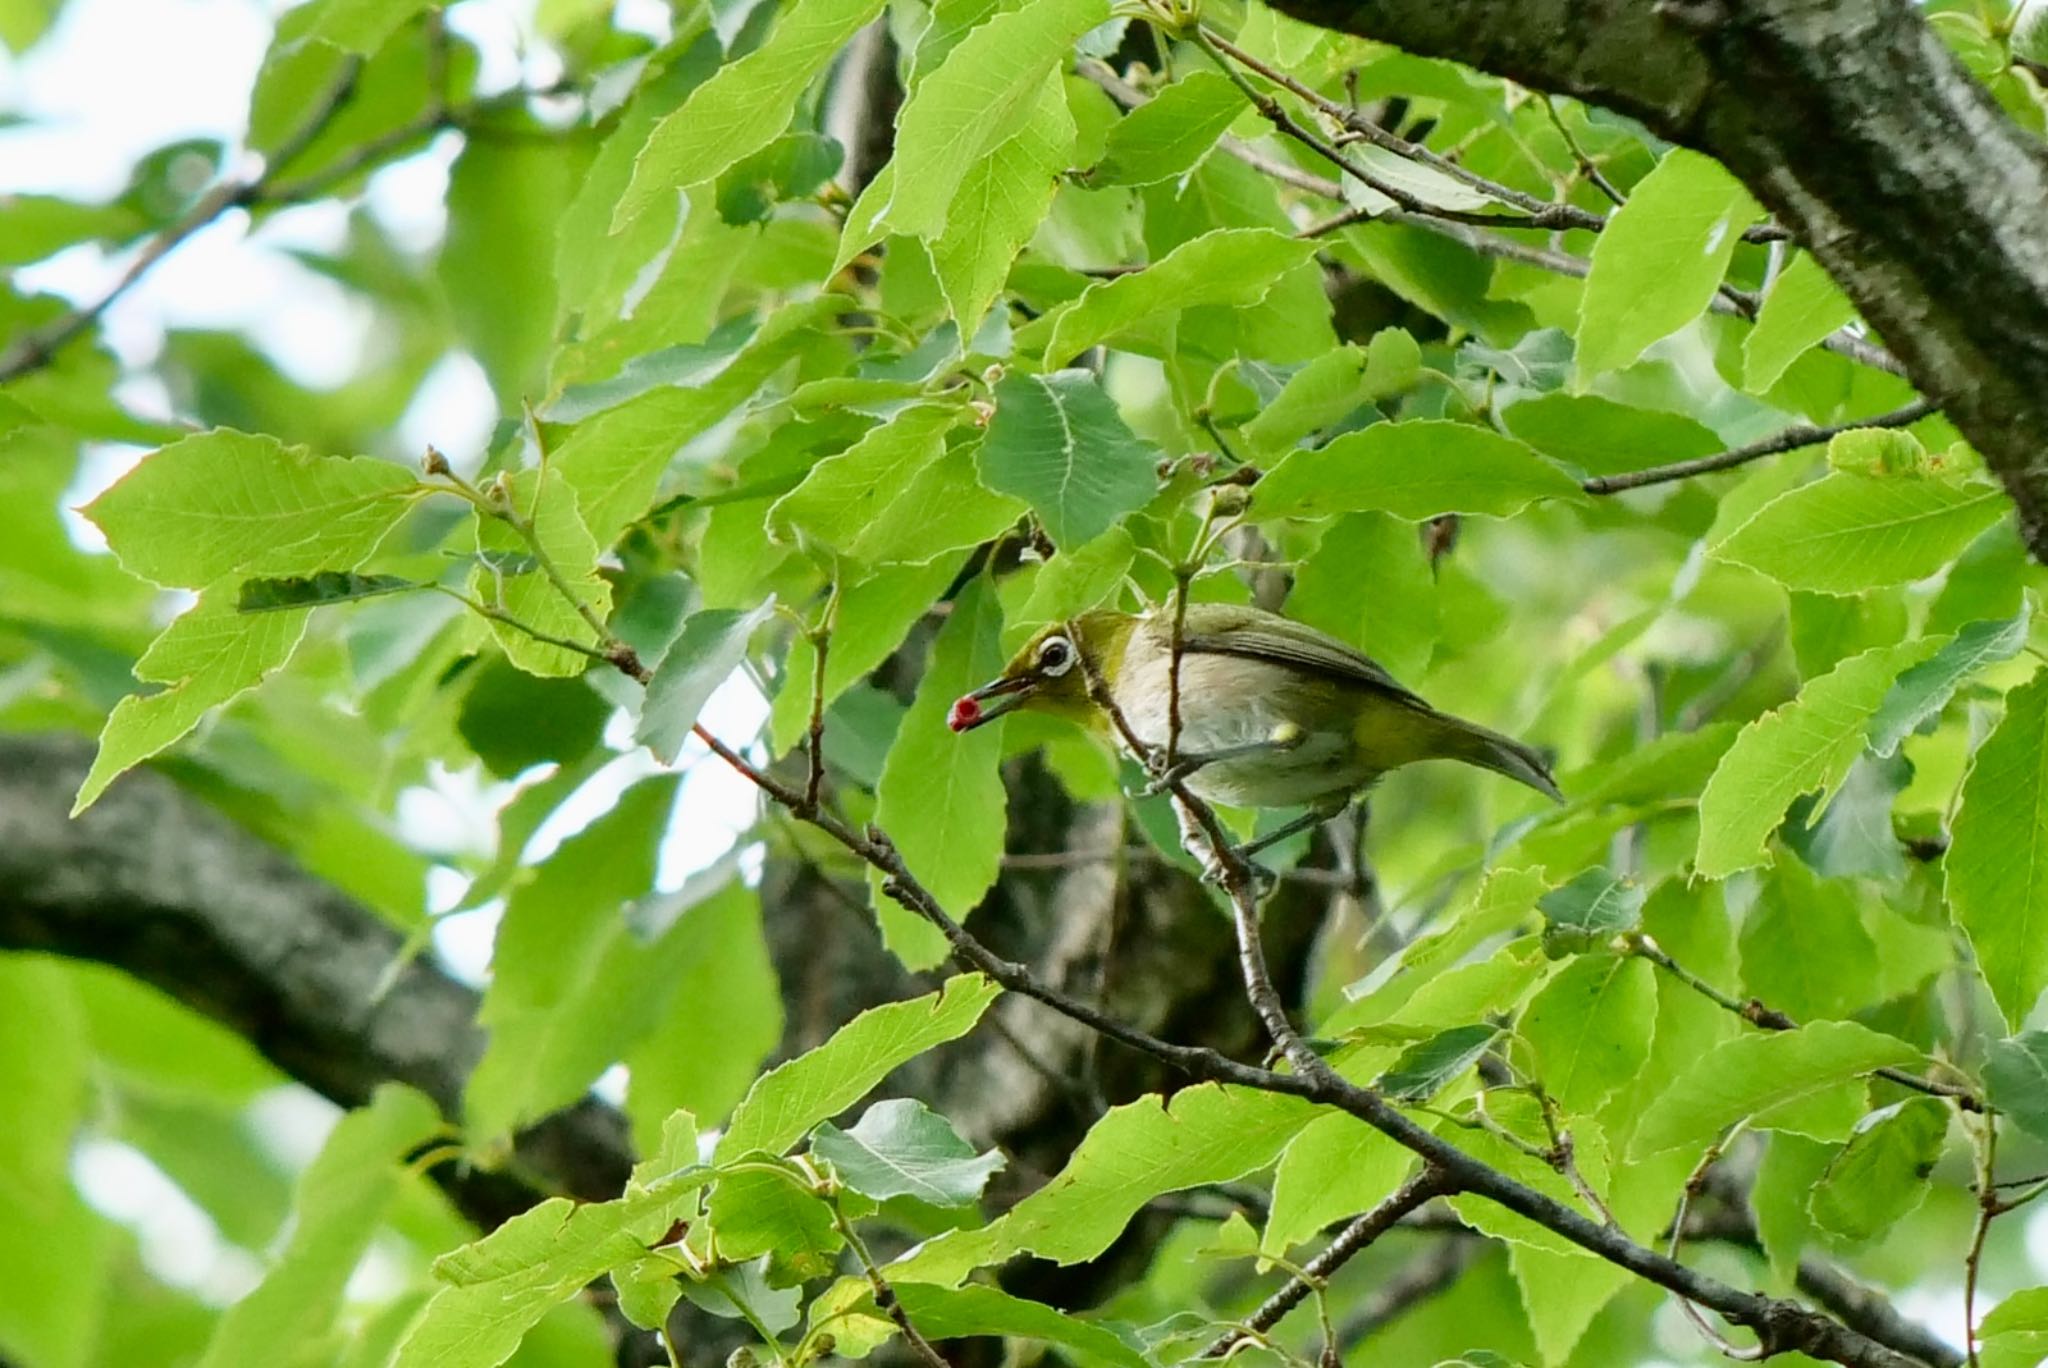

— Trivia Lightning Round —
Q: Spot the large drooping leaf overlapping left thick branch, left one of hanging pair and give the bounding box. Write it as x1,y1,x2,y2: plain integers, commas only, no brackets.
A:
463,778,680,1137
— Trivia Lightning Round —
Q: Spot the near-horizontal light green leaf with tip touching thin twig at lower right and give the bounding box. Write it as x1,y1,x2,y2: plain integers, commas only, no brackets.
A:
1630,1022,1921,1159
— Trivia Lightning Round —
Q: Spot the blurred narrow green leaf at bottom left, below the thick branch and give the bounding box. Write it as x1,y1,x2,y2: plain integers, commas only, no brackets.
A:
201,1083,440,1368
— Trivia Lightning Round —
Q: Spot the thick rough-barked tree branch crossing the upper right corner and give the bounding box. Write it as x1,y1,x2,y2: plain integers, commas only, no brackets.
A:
1278,0,2048,561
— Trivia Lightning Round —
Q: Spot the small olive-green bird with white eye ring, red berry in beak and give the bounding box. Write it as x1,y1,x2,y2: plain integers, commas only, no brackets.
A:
946,604,1565,874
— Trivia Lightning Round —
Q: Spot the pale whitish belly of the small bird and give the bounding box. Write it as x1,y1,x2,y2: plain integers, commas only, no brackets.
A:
1116,655,1376,807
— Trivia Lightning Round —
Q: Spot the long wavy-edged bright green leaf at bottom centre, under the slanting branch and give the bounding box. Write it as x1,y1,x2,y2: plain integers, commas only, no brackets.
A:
889,1083,1315,1286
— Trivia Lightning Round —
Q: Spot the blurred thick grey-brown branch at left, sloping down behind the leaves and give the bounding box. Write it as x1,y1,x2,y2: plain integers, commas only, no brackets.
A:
0,735,633,1229
